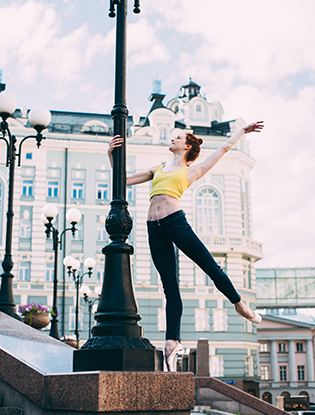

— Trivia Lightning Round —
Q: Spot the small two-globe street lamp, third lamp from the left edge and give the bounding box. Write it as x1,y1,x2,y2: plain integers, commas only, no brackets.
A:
63,255,95,344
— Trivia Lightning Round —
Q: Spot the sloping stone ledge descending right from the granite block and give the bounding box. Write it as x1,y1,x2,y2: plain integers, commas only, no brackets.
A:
195,377,290,415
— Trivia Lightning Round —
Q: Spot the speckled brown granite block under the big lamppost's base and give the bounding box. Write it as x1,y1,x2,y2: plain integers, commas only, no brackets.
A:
44,372,194,412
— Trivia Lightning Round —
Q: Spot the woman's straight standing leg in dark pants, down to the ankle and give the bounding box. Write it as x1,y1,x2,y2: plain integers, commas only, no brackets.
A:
148,221,183,344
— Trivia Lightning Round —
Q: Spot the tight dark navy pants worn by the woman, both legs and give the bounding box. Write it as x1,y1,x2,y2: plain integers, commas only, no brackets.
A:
147,210,241,340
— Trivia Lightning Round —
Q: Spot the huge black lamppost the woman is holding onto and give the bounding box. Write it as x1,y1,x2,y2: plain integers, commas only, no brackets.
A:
73,0,163,371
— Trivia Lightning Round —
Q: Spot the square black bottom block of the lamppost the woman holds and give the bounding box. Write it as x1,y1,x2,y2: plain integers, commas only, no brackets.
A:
73,349,163,372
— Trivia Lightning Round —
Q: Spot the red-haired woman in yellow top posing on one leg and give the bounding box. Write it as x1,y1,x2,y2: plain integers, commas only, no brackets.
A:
108,121,263,371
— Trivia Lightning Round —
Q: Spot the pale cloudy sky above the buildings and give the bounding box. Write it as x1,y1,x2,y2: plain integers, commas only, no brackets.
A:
0,0,315,268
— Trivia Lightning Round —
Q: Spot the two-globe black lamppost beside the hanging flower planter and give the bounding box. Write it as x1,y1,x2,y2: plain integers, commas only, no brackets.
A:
42,203,81,340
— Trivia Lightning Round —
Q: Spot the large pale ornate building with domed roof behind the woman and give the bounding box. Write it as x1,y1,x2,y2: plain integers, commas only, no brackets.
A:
0,80,262,381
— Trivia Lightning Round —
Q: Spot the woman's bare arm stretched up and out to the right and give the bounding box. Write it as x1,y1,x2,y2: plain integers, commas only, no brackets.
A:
187,121,264,184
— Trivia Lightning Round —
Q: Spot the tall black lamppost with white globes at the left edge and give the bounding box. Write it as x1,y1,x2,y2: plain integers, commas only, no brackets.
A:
0,90,51,318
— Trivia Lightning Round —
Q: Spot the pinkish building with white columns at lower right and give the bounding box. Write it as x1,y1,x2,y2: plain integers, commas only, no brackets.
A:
257,309,315,405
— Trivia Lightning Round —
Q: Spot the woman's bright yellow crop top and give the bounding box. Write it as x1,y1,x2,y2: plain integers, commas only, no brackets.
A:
150,164,189,200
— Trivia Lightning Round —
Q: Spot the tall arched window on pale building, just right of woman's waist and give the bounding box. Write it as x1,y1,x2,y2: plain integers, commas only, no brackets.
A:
196,187,221,236
